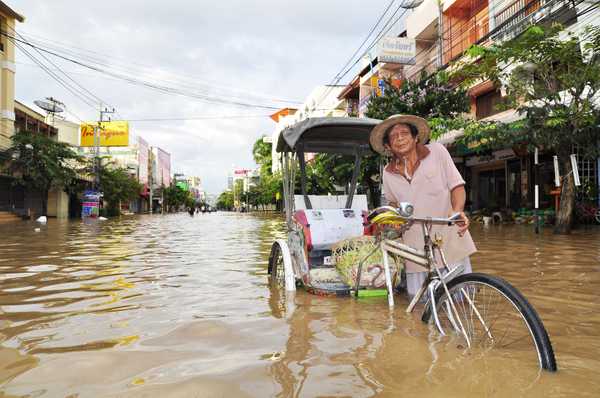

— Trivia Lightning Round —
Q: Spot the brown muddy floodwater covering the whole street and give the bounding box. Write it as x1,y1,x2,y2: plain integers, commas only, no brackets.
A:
0,213,600,398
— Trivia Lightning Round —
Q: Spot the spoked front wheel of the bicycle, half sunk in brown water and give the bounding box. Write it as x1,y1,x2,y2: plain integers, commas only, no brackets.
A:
423,273,557,372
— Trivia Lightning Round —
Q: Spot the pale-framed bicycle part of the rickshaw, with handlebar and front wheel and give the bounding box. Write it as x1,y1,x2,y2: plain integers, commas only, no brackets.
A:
354,203,557,372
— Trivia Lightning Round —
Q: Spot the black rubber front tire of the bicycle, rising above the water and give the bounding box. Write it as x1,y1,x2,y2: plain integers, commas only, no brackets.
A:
422,273,557,372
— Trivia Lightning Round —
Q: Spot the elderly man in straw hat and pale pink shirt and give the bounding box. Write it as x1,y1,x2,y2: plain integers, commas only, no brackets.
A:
370,115,476,296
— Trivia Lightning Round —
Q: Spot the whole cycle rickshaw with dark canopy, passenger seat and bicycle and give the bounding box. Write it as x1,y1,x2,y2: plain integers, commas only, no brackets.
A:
268,117,557,371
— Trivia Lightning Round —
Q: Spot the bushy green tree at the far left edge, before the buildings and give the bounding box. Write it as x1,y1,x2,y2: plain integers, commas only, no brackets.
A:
0,131,81,214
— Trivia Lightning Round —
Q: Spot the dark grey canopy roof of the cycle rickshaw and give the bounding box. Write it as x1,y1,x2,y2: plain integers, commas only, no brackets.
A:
276,117,381,155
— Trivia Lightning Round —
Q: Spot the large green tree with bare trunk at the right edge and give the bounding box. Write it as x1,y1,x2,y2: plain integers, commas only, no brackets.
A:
455,25,600,234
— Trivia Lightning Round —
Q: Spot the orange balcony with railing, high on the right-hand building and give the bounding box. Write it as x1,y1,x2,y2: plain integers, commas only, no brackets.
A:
442,0,489,64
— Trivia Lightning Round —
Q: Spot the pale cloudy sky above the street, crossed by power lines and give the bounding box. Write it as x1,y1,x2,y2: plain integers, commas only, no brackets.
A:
5,0,406,194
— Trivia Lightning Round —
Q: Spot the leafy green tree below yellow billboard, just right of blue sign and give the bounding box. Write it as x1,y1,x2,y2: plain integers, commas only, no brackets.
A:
99,162,142,216
